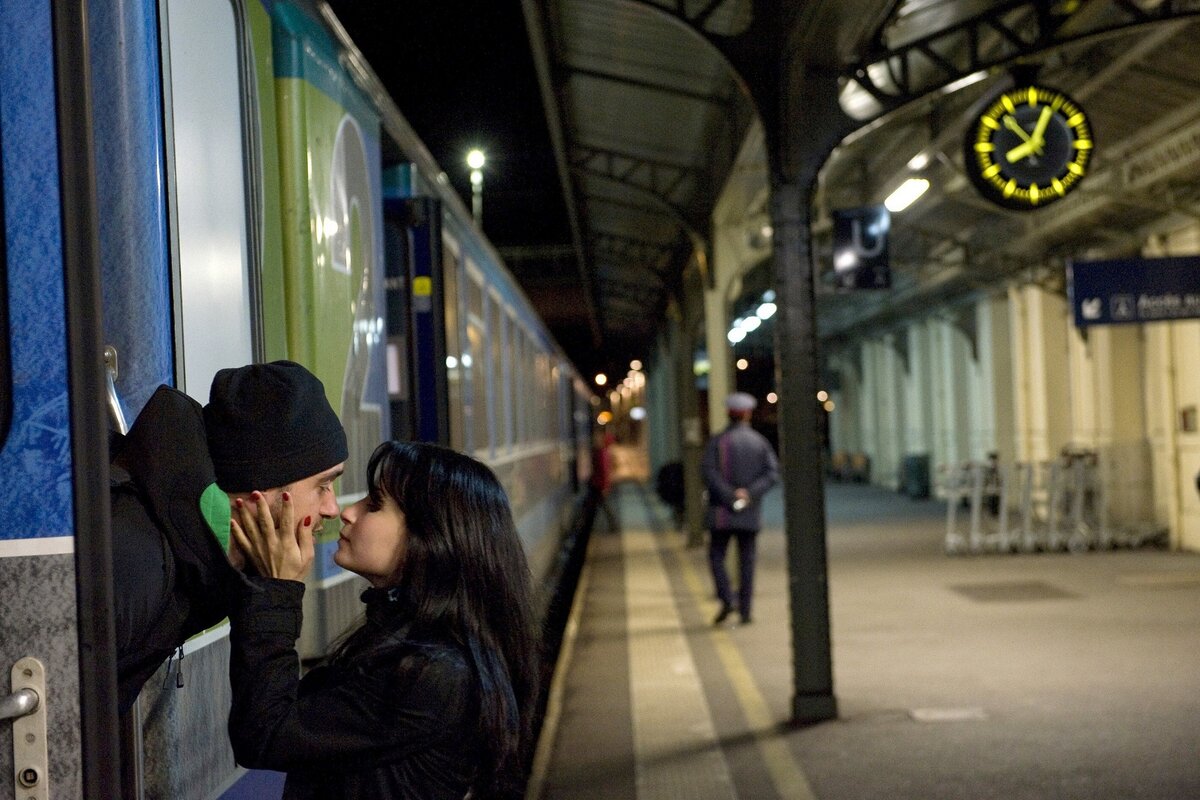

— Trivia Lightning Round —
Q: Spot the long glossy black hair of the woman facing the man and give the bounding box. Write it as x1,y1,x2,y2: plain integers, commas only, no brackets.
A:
335,441,539,799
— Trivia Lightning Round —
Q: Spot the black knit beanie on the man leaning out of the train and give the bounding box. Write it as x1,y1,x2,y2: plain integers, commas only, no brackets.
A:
204,361,349,492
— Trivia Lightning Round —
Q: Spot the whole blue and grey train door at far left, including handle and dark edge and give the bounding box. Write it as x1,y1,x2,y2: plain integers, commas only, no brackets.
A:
0,0,118,799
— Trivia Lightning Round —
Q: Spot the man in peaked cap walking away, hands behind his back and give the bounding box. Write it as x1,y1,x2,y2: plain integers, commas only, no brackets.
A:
703,392,779,625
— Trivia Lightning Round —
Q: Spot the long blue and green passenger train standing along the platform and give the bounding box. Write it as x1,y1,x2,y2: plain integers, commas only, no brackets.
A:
0,0,594,800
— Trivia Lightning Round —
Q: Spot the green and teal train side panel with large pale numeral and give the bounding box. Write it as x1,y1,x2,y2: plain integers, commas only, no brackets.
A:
274,4,389,657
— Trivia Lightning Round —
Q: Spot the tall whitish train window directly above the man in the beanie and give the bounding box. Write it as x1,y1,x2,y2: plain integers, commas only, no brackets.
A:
161,0,260,402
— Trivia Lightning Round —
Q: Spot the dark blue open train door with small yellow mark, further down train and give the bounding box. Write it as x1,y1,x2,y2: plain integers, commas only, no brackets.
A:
384,197,450,445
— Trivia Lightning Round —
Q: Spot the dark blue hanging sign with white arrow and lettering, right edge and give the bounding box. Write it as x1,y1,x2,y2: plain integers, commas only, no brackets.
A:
1067,255,1200,327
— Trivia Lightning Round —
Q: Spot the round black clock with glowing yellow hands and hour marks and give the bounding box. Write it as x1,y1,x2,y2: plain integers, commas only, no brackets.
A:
964,85,1094,210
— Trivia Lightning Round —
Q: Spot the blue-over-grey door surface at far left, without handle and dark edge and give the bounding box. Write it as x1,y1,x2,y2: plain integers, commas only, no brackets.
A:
0,0,83,796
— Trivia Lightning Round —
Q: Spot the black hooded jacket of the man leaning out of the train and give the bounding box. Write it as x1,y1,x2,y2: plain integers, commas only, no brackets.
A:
109,386,245,714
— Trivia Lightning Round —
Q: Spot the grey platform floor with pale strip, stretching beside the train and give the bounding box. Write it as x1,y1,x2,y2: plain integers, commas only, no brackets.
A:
527,465,1200,800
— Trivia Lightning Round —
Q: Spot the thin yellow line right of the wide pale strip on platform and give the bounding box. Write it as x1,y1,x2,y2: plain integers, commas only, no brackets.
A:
667,536,817,800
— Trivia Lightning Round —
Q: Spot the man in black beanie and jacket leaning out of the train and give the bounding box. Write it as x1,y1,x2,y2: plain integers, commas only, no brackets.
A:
109,361,347,714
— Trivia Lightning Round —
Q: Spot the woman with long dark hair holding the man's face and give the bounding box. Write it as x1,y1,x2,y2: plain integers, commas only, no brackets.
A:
229,441,538,800
